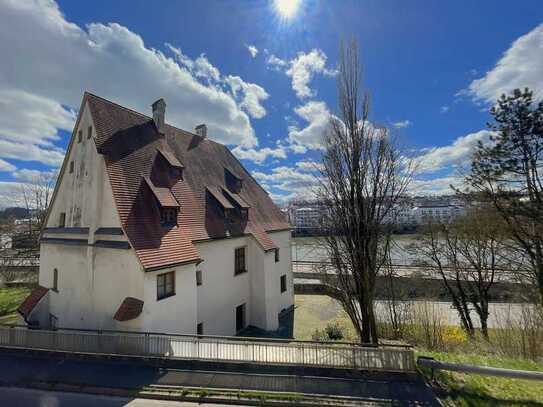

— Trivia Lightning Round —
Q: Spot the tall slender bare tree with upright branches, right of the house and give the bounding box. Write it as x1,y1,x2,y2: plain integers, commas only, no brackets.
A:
318,41,413,343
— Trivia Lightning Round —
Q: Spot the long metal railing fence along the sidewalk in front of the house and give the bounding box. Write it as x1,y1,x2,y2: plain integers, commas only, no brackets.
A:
0,325,415,371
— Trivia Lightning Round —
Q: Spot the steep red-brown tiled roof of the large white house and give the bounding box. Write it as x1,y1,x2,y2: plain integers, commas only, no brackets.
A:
85,93,289,269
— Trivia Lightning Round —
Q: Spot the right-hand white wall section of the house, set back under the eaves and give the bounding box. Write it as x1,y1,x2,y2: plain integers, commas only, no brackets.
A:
193,231,294,335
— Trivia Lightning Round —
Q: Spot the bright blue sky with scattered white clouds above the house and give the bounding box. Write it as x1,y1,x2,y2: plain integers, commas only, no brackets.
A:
0,0,543,206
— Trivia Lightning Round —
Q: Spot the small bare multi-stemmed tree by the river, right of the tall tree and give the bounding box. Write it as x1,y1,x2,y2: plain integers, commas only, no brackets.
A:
412,208,511,339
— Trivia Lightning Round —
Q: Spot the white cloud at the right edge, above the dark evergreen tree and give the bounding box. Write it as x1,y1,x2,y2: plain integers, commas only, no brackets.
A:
468,24,543,103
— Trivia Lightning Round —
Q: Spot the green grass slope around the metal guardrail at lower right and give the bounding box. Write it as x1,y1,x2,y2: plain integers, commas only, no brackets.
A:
418,352,543,407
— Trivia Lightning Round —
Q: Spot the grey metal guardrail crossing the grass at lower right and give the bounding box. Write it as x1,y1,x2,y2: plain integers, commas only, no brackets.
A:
417,356,543,381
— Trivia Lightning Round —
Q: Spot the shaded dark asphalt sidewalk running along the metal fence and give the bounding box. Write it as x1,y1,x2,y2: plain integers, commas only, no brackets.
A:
0,353,437,406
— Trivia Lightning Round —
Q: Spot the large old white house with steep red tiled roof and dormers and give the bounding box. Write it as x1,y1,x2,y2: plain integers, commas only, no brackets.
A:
19,93,294,335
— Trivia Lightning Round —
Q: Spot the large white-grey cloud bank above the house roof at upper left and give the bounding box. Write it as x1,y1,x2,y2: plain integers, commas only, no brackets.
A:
0,0,264,151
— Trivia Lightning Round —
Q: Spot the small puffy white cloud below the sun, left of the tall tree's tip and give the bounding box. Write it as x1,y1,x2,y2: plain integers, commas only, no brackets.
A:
286,49,335,99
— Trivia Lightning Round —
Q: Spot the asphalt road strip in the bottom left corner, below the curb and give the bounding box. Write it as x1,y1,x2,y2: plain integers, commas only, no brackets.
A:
0,387,241,407
